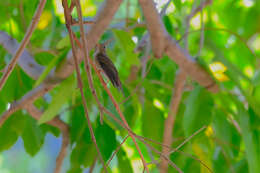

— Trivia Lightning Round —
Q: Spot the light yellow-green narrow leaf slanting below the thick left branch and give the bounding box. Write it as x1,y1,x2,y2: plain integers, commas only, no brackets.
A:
38,75,75,124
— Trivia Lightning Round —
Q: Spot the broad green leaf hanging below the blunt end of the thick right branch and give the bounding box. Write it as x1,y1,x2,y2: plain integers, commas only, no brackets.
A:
183,86,214,137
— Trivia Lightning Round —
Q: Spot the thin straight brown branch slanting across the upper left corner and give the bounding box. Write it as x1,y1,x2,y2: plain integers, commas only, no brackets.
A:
0,0,46,91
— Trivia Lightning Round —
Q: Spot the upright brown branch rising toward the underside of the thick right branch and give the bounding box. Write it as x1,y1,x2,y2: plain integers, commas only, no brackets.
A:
160,71,186,173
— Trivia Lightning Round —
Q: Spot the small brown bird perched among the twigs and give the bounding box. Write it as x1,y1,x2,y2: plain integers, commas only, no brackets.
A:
94,43,122,91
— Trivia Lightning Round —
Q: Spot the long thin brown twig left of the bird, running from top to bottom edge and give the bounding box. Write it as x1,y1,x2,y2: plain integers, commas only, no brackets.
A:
62,0,108,172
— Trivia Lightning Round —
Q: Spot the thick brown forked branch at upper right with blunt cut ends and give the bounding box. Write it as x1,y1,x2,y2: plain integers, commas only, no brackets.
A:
139,0,218,92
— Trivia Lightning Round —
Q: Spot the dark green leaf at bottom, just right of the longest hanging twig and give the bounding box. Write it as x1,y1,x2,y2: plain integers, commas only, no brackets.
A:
95,121,116,161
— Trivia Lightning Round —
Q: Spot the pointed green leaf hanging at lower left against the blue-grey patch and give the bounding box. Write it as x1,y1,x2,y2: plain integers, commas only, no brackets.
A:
22,116,45,156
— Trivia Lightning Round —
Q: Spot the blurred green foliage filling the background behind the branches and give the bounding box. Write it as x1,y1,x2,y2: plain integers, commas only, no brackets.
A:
0,0,260,173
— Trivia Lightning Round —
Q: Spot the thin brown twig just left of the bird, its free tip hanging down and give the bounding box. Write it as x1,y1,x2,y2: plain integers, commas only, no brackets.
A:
75,0,103,124
